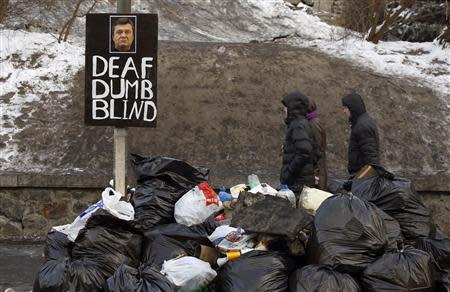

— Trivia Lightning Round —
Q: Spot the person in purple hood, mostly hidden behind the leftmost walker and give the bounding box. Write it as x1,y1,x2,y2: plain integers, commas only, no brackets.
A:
306,97,328,191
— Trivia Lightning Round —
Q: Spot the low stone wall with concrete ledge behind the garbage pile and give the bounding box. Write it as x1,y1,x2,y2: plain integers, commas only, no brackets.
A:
0,175,450,240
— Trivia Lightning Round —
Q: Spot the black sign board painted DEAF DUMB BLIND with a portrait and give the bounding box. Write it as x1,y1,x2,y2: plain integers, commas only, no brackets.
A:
85,14,158,127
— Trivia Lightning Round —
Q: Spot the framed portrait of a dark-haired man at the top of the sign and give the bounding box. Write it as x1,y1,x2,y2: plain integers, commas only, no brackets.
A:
110,16,136,53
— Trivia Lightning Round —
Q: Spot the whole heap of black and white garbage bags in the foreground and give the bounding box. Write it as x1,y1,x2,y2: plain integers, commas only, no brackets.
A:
33,155,450,292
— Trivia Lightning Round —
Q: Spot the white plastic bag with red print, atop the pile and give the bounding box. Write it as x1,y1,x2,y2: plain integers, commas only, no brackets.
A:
174,182,223,226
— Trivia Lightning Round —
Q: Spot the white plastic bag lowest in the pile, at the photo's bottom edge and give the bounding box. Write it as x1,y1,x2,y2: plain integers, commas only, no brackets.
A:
161,256,217,291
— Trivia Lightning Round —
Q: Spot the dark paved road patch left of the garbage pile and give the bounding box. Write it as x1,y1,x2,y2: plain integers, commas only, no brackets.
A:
0,242,44,292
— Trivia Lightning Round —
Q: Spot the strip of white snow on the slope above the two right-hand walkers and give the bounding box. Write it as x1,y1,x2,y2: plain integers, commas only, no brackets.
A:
248,0,450,101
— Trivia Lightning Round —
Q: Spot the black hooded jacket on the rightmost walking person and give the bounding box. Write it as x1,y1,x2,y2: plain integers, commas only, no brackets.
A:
342,94,380,174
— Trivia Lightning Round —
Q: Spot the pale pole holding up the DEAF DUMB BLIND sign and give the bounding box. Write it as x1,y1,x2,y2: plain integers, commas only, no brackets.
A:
114,0,131,195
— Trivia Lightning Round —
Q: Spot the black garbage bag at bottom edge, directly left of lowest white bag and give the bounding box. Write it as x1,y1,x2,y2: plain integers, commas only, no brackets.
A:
105,265,175,292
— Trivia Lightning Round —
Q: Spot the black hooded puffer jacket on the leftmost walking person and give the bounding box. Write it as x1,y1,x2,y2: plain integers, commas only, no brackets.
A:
280,91,320,187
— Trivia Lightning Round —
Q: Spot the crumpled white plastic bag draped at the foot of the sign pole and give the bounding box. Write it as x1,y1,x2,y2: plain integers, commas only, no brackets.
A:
53,188,134,241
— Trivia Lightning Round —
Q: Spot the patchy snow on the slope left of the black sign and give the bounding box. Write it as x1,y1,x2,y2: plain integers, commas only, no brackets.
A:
0,30,84,164
